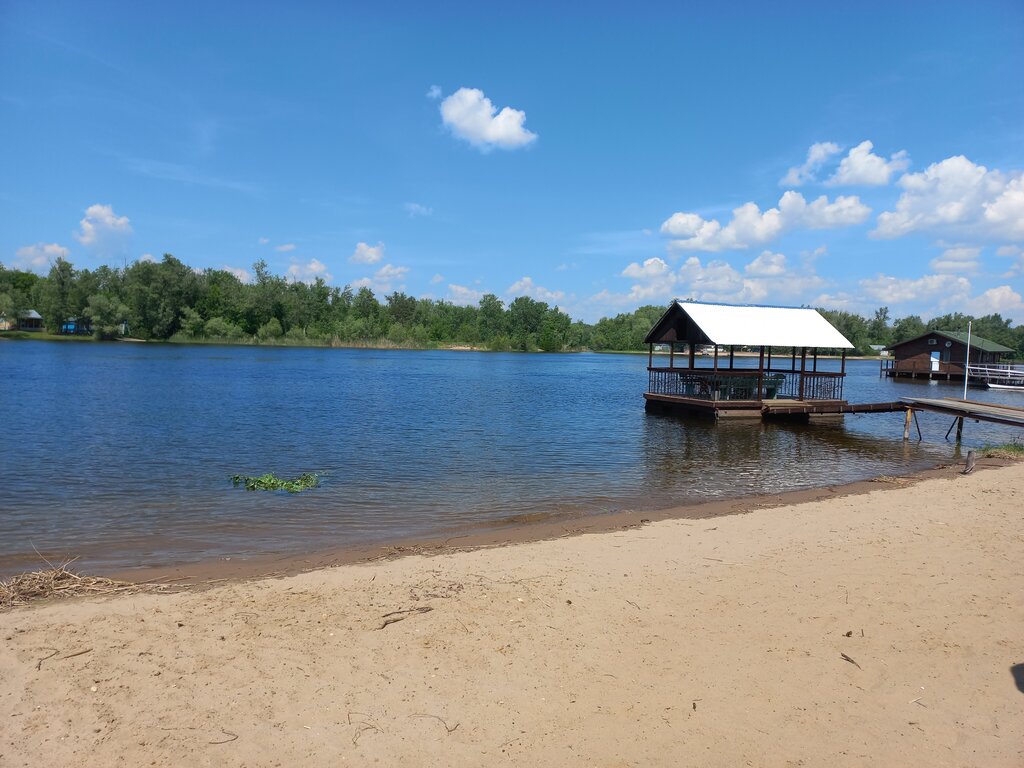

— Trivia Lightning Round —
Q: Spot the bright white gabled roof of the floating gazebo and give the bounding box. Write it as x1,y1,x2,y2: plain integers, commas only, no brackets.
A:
644,301,853,349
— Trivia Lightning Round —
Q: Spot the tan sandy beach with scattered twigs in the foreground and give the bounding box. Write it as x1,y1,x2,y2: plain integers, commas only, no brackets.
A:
0,464,1024,768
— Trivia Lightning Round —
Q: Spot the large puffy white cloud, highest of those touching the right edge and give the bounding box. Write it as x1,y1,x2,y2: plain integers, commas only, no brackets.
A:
871,155,1024,241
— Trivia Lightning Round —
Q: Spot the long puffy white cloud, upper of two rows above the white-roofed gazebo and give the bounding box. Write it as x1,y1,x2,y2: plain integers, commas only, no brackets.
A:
662,190,871,253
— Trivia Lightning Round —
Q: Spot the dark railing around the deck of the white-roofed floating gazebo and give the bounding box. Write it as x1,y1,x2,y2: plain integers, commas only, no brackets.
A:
647,368,844,401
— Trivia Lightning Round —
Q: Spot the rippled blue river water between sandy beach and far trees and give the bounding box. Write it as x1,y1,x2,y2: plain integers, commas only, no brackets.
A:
0,342,1024,573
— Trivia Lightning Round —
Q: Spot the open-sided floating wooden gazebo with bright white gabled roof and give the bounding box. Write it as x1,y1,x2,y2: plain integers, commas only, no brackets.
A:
644,301,853,418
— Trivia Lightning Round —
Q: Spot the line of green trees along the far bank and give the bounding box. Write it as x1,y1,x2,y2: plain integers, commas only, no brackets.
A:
0,254,1024,356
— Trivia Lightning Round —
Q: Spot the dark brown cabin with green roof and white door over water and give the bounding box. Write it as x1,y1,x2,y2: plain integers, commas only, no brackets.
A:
883,331,1014,381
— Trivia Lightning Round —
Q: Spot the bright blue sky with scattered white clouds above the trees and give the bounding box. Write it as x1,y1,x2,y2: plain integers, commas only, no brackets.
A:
0,0,1024,323
